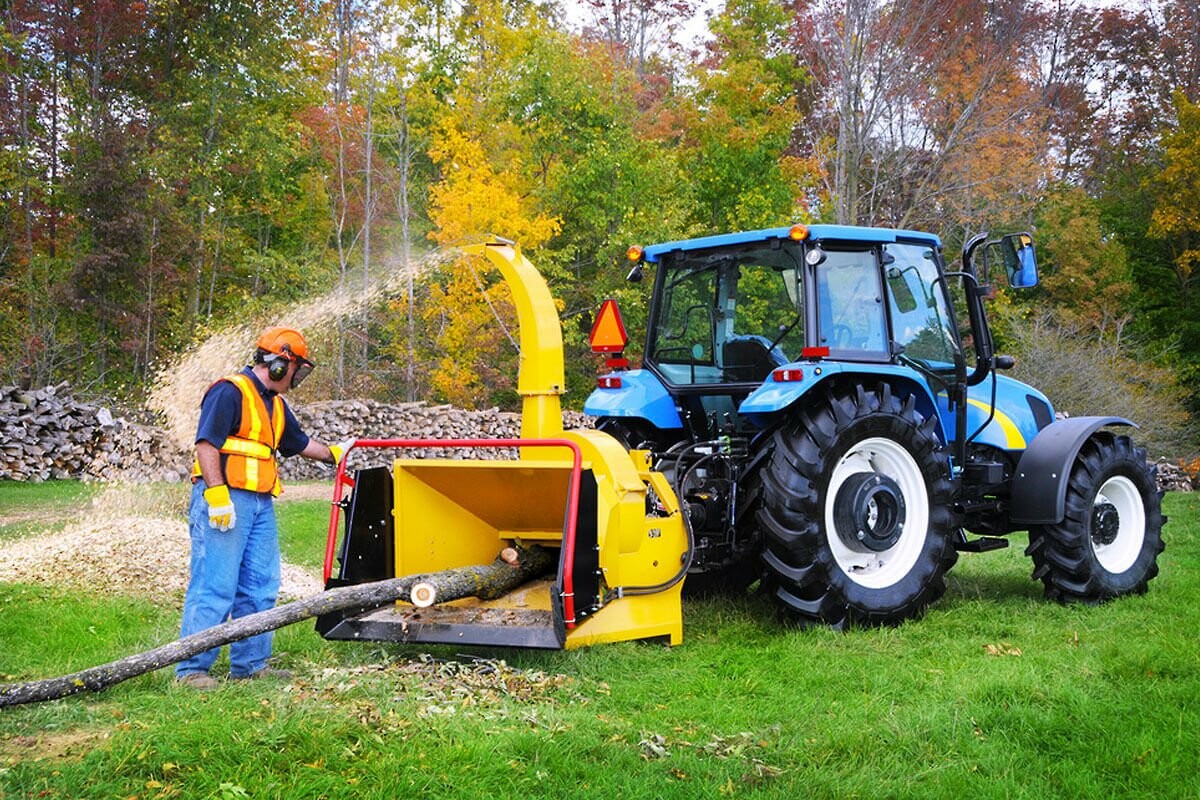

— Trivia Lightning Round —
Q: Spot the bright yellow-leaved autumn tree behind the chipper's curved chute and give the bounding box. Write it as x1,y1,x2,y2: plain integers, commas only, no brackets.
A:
398,1,559,408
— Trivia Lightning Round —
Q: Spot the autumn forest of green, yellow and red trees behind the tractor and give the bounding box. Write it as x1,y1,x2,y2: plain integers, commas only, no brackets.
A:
0,0,1200,465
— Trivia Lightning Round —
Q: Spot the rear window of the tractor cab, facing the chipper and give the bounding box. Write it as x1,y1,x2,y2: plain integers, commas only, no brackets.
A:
649,243,804,384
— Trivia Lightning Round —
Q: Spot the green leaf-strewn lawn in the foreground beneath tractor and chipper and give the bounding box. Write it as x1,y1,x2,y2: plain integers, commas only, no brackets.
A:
0,484,1200,800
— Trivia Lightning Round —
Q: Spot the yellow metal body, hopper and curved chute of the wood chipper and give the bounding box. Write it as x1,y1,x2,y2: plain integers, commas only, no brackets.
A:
392,242,688,648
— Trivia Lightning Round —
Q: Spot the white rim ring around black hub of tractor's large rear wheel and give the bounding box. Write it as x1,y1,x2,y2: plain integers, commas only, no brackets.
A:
824,437,929,589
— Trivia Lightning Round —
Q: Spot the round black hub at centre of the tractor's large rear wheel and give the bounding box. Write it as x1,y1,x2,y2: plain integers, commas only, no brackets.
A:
834,473,905,553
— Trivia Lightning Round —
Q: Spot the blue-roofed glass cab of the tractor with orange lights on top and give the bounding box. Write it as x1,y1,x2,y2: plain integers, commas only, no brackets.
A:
587,225,965,439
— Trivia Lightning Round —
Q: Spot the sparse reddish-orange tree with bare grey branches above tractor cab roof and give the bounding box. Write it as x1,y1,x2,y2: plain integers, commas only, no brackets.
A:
797,0,1042,228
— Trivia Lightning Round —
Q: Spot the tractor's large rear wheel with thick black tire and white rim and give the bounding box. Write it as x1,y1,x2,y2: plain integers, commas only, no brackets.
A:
758,384,959,628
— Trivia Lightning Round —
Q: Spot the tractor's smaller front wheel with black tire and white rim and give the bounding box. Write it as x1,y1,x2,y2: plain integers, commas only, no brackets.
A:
1025,432,1165,603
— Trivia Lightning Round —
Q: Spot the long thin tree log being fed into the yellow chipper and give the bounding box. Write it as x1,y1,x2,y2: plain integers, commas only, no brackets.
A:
0,547,554,708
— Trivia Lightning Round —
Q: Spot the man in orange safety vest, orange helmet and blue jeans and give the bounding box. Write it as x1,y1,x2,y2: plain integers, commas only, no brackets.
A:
175,327,354,690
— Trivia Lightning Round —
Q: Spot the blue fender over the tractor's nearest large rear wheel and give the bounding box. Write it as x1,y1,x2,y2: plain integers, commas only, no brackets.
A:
738,361,947,444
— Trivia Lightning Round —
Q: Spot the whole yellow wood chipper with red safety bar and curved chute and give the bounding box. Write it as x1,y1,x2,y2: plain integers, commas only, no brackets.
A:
317,241,691,649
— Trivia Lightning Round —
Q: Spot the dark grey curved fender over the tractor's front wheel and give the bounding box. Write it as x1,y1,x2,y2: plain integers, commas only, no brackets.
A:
1012,416,1138,525
